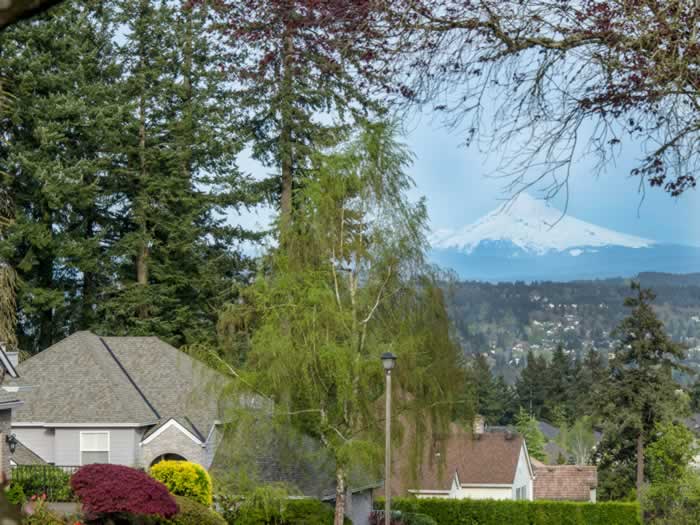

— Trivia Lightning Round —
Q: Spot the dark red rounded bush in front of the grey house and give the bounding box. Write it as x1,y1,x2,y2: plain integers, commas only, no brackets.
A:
70,464,178,520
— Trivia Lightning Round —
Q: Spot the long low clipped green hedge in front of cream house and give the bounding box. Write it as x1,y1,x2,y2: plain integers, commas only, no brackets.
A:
375,498,642,525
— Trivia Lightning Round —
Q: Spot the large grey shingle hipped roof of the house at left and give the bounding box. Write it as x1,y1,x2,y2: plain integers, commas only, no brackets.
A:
14,332,225,437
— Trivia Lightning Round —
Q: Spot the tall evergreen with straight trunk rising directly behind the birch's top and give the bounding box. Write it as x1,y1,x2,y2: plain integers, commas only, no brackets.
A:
220,0,388,238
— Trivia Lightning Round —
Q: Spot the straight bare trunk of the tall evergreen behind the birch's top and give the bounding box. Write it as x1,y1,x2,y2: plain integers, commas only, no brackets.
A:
279,23,294,239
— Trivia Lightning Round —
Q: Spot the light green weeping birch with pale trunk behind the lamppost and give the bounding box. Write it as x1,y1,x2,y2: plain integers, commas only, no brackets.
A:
212,124,462,524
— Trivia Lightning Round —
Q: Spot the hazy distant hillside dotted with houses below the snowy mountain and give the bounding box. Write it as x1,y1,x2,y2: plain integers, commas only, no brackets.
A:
449,273,700,380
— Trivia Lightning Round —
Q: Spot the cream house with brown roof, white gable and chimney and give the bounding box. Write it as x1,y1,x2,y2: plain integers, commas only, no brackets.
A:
400,425,534,500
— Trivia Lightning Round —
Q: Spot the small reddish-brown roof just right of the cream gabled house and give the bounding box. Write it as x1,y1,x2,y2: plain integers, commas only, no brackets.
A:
532,460,598,501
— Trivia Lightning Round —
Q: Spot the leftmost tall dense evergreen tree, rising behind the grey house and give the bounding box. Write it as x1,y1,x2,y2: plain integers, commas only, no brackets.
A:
0,2,123,351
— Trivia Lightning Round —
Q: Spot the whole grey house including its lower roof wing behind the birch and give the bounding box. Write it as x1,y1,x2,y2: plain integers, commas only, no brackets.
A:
5,332,376,524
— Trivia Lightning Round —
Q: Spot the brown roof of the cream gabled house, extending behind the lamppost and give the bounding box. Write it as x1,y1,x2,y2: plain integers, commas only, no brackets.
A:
392,425,523,495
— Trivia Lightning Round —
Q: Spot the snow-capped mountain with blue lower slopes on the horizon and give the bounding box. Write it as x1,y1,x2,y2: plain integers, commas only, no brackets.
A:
432,194,700,281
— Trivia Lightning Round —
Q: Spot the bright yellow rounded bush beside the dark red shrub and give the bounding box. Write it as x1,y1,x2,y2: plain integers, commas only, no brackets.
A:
150,461,212,506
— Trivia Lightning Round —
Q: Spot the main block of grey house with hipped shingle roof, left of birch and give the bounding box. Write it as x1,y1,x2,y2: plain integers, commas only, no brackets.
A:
6,332,225,468
